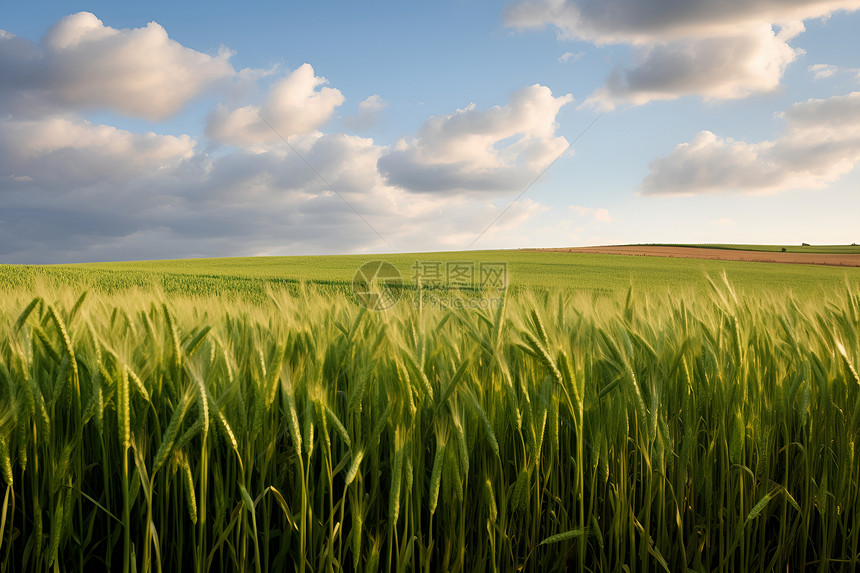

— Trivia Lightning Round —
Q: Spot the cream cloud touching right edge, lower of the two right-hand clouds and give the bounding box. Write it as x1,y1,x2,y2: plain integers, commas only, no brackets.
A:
640,92,860,195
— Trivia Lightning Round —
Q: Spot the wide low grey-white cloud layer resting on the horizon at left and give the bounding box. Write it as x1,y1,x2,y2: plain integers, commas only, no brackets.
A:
0,111,546,263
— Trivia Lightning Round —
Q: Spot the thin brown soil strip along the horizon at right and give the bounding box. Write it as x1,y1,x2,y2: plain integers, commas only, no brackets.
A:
527,245,860,267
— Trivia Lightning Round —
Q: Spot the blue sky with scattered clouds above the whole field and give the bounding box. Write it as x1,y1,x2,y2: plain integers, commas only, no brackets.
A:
0,0,860,263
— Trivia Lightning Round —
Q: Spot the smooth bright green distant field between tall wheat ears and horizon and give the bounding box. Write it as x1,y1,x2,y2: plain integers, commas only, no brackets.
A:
0,250,860,298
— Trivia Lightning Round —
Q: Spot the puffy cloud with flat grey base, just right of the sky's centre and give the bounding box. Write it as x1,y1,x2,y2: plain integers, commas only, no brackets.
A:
379,84,573,192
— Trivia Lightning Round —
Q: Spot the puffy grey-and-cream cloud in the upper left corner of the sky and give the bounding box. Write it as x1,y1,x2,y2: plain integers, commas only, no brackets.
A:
0,12,234,120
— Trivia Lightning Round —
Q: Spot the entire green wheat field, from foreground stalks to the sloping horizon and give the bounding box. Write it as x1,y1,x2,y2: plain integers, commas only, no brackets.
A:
0,251,860,572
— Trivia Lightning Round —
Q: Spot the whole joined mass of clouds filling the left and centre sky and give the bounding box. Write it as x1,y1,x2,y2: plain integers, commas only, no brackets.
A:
0,12,572,263
